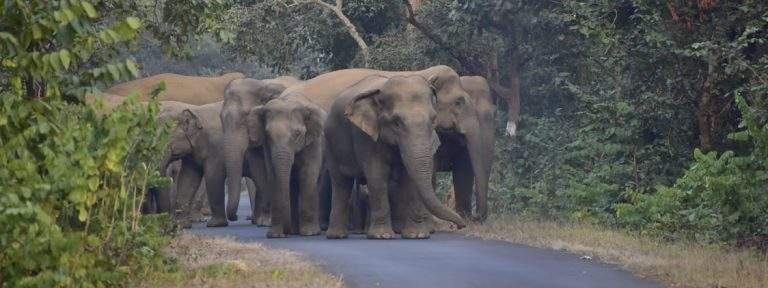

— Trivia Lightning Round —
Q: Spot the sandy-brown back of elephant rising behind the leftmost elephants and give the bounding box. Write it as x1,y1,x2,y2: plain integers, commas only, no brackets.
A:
107,73,245,105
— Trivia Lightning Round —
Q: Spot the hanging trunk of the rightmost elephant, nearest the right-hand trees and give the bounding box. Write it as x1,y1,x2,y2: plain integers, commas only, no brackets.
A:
466,132,493,221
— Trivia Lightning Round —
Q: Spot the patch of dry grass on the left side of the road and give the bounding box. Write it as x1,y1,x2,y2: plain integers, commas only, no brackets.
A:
137,234,344,287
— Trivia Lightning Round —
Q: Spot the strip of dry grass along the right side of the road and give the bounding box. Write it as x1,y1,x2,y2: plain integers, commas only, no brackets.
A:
459,216,768,288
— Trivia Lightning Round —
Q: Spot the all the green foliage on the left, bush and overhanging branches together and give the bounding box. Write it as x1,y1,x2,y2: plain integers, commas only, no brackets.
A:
0,1,222,287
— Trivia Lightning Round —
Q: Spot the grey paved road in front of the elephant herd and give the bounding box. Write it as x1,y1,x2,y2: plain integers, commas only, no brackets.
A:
189,198,662,288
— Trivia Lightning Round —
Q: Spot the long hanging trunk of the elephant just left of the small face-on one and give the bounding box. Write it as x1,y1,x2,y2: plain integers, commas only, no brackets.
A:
223,131,248,221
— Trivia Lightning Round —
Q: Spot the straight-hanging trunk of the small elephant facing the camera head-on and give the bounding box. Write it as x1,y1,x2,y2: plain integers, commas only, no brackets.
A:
270,148,294,229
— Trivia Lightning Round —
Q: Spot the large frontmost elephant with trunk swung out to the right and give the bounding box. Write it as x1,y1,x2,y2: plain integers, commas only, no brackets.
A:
324,73,465,239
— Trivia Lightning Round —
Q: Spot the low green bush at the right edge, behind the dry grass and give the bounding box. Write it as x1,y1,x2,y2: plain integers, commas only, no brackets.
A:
616,96,768,242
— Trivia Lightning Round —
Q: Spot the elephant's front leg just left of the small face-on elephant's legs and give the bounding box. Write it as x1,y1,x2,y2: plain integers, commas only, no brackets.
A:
247,151,272,226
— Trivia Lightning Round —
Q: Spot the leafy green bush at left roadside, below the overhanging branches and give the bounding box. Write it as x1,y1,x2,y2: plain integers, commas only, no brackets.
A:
0,93,167,287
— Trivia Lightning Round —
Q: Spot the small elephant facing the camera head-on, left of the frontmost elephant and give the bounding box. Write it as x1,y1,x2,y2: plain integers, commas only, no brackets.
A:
247,93,326,238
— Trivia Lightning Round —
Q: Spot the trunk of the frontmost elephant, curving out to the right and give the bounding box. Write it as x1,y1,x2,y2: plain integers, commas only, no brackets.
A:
400,136,466,229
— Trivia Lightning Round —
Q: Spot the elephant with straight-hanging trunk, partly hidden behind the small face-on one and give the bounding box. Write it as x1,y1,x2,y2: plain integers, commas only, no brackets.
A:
219,76,301,226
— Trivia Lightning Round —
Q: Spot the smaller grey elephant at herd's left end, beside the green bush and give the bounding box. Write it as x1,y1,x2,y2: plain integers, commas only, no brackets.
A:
161,102,228,227
